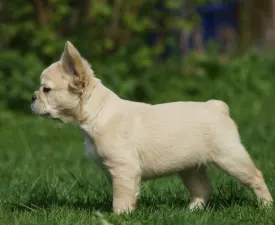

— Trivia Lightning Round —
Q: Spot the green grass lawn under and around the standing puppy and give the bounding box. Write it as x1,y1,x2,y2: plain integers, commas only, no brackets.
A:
0,104,275,225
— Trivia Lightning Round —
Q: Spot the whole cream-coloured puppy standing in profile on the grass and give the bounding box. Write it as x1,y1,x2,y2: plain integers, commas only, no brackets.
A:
31,42,272,213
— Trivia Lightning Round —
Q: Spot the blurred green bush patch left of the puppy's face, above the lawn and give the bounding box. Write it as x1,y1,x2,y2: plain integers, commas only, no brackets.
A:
0,51,43,110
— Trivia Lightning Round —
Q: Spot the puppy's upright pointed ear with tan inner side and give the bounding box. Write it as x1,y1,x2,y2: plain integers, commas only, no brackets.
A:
61,41,84,76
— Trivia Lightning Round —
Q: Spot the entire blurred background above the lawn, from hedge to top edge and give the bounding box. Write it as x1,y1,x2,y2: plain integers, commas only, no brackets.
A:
0,0,275,113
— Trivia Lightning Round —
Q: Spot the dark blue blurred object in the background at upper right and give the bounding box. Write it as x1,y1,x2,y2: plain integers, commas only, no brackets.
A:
197,1,238,43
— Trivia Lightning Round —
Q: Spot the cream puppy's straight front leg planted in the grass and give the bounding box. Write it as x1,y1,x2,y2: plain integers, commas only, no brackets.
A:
110,165,141,213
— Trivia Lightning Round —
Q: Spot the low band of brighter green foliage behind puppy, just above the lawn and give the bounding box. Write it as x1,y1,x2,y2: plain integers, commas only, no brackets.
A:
0,49,275,114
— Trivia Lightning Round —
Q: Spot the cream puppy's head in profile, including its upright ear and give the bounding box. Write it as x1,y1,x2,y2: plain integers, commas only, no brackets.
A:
31,42,95,121
